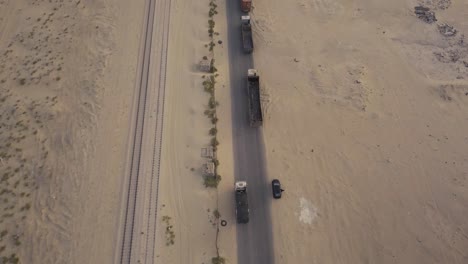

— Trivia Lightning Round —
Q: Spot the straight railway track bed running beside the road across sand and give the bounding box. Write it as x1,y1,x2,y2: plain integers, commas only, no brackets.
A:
116,0,171,263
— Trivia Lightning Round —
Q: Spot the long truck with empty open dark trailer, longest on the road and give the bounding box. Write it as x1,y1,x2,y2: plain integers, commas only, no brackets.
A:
247,69,263,127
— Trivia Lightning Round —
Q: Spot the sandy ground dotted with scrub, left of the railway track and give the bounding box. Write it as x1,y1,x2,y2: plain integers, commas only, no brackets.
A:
0,0,144,263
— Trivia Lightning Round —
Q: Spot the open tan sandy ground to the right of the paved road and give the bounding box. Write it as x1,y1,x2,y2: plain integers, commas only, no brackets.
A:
252,0,468,263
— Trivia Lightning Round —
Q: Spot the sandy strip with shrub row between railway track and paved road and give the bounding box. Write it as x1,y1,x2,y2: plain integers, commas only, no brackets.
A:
157,0,235,263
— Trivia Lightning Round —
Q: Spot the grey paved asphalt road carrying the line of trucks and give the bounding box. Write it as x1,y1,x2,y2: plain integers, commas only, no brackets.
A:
227,0,274,264
